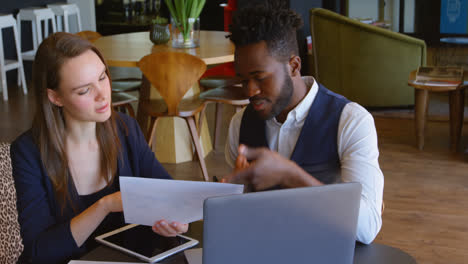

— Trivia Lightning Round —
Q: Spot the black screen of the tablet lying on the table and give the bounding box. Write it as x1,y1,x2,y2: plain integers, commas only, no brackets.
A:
102,225,189,258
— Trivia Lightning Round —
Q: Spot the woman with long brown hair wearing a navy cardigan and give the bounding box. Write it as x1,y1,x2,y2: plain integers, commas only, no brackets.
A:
11,32,188,263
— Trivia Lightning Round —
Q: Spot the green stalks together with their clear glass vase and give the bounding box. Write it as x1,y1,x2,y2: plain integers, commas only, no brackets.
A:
165,0,206,48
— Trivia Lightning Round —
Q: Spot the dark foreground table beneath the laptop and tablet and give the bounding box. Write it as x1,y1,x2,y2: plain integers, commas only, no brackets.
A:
81,221,416,264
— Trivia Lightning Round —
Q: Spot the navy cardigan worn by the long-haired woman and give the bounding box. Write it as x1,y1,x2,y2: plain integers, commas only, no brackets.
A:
11,113,171,264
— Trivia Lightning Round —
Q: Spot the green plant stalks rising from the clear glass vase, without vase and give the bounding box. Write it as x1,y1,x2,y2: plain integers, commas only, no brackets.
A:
164,0,206,41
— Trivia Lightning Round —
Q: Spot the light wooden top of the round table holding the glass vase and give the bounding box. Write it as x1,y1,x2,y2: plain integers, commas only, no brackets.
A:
94,30,234,67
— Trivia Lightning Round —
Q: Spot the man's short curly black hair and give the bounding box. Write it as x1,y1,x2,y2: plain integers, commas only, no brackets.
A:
229,0,303,62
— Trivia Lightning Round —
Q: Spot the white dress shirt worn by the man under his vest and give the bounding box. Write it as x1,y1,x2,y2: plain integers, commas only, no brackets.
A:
225,77,384,244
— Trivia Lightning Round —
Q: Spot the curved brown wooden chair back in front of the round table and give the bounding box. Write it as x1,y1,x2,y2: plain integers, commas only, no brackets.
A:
138,52,206,115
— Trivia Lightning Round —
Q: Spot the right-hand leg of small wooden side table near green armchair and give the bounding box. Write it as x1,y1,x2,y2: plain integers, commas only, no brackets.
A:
449,88,465,152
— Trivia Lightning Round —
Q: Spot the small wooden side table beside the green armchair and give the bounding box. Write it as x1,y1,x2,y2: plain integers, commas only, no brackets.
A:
408,71,468,152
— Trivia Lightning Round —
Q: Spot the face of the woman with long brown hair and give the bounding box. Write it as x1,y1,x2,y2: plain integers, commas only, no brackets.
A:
47,50,111,122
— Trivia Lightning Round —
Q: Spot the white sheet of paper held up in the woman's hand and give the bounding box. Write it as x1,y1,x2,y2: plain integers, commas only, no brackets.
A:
120,176,244,226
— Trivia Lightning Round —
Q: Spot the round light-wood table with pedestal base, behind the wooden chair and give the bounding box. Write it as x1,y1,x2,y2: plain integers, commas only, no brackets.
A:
94,31,234,163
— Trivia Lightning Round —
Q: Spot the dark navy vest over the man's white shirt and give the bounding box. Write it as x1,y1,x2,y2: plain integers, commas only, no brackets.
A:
239,84,350,184
